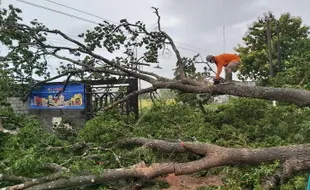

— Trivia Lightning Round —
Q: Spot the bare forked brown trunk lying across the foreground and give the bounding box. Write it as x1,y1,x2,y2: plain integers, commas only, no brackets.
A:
1,138,310,190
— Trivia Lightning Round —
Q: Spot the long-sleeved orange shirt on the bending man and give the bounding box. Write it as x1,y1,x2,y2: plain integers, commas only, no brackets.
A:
214,53,240,79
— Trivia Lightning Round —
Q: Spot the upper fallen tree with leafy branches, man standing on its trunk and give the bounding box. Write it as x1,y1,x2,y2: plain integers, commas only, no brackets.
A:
1,7,310,107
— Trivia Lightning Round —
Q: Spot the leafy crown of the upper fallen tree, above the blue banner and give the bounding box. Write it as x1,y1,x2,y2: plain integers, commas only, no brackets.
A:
0,5,179,84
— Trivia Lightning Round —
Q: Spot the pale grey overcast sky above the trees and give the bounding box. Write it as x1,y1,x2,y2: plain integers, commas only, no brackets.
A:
1,0,310,87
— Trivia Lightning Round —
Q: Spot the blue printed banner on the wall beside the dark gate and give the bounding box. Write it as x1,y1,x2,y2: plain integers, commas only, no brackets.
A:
29,83,86,110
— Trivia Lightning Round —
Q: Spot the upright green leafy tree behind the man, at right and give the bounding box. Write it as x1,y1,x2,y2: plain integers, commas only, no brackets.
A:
235,12,309,82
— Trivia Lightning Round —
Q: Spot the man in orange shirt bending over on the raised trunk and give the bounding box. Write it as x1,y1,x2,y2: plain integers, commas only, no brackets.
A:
207,53,240,84
